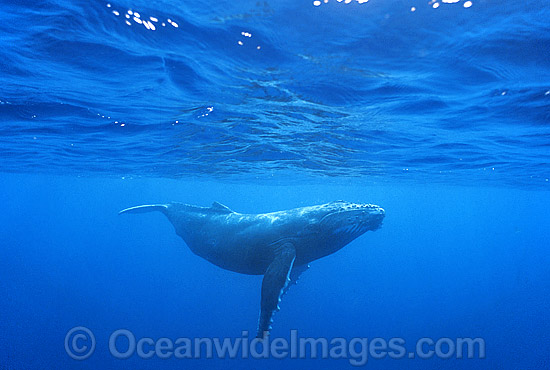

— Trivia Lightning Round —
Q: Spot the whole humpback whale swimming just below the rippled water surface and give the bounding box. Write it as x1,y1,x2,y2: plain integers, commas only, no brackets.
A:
119,201,385,338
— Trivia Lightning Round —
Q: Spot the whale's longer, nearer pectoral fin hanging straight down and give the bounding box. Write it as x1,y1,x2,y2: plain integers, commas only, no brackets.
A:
256,243,296,338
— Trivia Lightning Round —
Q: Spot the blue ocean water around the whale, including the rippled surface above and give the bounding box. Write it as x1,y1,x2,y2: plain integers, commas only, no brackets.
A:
0,0,550,369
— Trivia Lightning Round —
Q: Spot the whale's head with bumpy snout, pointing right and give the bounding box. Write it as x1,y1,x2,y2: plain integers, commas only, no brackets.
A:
319,201,386,250
